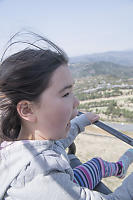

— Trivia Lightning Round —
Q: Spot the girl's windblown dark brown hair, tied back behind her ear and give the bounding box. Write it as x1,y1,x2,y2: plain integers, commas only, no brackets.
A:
0,33,68,140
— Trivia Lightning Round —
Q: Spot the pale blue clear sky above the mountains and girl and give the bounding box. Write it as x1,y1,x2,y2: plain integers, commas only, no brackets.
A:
0,0,133,57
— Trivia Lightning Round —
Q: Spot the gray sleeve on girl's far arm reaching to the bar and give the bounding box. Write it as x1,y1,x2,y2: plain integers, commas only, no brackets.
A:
59,114,91,149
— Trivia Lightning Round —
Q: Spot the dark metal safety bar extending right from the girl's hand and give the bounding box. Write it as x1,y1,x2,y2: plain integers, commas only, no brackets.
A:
78,112,133,146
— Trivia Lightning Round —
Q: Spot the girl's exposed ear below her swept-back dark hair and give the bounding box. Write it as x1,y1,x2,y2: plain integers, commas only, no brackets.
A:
17,100,36,122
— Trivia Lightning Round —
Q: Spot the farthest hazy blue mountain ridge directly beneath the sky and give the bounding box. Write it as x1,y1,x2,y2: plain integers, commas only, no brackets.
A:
70,50,133,66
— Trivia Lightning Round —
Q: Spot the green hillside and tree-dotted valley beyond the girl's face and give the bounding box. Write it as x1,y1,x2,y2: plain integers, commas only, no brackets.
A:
70,52,133,122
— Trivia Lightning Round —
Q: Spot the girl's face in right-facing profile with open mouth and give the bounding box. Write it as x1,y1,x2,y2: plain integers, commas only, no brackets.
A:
34,65,79,140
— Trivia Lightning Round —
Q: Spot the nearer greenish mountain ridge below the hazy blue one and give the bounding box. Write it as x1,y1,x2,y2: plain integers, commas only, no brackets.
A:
70,61,133,78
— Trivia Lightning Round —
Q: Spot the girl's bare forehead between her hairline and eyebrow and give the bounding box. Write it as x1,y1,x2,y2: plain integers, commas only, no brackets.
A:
51,65,74,86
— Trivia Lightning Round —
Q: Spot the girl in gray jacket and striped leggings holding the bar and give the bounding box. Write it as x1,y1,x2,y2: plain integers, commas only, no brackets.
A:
0,32,133,200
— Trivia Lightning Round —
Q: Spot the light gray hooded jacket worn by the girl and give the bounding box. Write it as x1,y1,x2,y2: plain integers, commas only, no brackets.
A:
0,115,133,200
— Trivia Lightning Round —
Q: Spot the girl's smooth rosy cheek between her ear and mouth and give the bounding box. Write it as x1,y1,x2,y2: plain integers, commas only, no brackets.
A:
40,98,73,134
